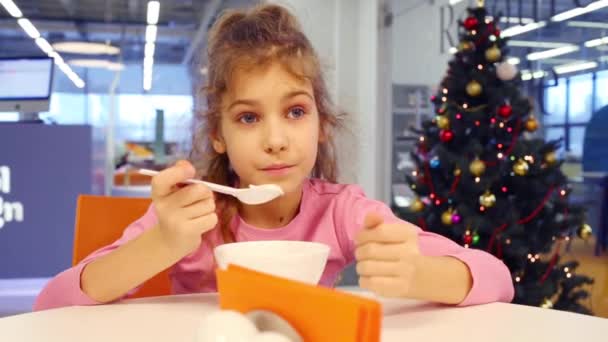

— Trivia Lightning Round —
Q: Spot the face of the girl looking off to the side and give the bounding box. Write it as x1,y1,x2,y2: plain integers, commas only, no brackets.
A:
213,63,320,193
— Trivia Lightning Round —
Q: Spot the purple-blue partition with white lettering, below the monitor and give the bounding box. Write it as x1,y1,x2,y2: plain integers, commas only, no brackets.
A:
0,123,92,278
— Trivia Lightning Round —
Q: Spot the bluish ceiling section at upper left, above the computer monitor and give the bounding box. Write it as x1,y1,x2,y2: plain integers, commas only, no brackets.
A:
0,0,252,64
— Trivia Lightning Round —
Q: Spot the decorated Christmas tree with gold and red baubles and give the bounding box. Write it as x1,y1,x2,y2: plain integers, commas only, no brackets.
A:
396,3,593,314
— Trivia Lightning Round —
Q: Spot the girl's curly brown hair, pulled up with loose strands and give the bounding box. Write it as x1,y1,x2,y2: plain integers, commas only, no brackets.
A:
190,4,344,246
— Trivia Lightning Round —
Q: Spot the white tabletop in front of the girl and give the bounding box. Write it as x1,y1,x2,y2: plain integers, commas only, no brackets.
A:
0,294,608,342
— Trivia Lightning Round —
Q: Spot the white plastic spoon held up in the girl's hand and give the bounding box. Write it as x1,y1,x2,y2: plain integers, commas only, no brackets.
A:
139,169,284,205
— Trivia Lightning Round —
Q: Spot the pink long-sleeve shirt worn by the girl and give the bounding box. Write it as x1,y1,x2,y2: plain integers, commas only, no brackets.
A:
34,179,514,310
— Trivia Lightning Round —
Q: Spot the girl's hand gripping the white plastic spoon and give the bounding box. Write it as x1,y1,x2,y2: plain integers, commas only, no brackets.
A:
152,160,218,255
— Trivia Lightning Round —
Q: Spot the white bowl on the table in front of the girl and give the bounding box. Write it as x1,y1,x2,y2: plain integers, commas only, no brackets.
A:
213,241,329,285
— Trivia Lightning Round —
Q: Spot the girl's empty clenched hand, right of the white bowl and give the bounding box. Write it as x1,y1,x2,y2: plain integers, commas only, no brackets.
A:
355,213,422,297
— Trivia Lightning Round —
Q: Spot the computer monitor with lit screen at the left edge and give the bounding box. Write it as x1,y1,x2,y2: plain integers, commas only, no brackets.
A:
0,57,54,118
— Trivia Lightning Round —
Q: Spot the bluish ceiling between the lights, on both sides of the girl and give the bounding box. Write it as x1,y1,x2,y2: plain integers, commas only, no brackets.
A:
0,0,608,76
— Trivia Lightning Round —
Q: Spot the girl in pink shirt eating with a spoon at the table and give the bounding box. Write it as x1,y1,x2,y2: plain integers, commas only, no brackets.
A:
35,5,513,310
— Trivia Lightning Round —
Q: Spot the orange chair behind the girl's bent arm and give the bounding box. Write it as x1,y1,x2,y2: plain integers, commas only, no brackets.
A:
72,195,171,298
